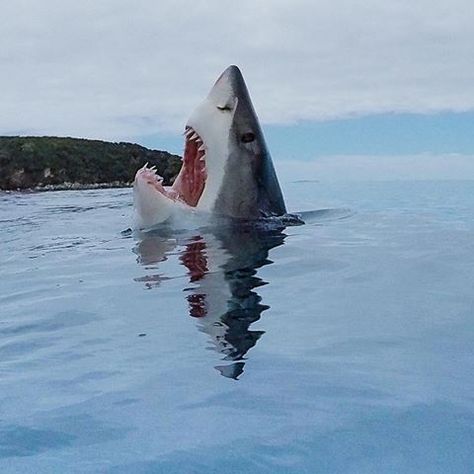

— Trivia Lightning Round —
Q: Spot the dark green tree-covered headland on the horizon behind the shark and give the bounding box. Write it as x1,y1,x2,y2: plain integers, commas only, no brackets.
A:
0,137,181,190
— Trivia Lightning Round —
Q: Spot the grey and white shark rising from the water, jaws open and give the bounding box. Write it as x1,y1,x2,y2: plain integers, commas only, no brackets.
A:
133,66,290,228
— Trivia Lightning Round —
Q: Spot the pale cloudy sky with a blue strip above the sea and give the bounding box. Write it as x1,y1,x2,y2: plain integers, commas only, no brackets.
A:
0,0,474,178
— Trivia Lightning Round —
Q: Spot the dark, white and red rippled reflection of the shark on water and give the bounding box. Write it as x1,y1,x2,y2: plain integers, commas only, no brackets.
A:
134,220,286,379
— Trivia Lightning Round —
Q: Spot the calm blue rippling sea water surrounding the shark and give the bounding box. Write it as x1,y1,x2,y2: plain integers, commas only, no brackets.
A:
0,181,474,473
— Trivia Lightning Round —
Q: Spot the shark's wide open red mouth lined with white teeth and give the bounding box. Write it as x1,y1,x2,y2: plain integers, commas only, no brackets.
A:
136,126,207,207
